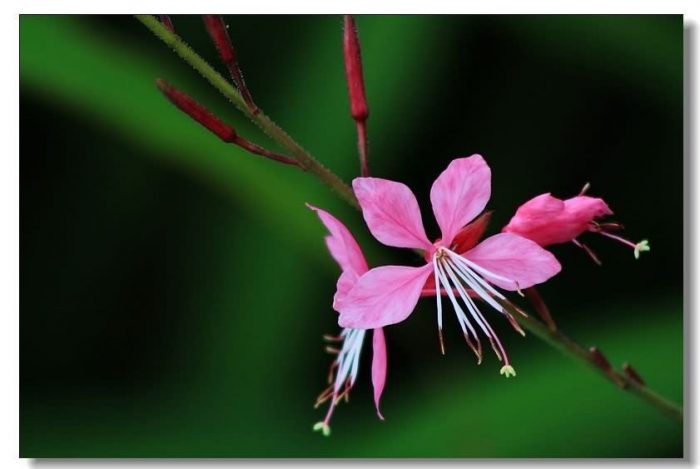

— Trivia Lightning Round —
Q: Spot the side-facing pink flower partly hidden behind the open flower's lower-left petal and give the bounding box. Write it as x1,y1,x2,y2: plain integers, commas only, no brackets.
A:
307,204,387,436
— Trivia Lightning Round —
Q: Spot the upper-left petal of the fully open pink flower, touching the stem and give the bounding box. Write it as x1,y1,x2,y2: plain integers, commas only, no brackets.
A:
352,178,432,250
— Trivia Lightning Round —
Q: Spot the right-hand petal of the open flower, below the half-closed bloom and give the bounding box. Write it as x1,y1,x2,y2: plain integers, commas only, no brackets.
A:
463,233,561,290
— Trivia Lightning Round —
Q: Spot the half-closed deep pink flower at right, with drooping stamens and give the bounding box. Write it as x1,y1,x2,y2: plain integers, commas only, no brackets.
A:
503,185,650,263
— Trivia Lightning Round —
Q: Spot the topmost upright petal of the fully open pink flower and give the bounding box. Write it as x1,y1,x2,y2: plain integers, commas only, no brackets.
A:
430,155,491,246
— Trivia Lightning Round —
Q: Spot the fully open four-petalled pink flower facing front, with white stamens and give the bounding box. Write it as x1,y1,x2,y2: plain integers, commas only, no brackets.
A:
334,155,561,377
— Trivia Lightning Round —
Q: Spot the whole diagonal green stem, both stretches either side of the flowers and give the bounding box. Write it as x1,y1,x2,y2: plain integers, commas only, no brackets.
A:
136,15,683,422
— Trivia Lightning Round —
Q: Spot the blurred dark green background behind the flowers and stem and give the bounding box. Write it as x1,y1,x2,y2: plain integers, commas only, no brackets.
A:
20,15,683,457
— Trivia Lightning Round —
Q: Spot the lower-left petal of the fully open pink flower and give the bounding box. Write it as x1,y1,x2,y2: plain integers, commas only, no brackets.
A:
334,264,432,329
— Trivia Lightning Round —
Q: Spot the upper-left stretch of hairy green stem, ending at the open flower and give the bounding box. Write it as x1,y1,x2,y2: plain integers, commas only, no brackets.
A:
136,15,359,208
